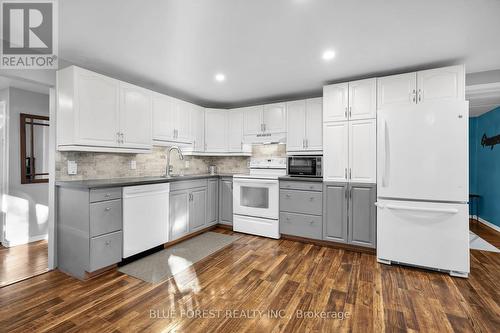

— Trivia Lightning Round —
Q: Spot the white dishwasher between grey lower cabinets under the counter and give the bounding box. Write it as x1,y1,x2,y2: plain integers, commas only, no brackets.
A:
122,183,170,258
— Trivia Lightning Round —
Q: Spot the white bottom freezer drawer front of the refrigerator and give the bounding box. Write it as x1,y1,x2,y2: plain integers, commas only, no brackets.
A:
377,200,469,274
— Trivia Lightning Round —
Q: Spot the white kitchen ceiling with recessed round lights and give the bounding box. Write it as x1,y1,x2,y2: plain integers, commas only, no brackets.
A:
59,0,500,106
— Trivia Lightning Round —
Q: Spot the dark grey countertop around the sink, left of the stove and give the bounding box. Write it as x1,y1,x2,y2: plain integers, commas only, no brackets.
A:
56,173,239,188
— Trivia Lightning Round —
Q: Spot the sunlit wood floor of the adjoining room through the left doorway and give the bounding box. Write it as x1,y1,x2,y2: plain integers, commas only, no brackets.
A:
0,240,48,287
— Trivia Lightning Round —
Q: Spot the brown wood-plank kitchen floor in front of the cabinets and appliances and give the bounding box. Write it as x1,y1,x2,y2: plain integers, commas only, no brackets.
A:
0,229,500,332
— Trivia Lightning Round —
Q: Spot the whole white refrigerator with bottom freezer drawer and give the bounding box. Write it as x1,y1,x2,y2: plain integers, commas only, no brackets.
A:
376,101,469,277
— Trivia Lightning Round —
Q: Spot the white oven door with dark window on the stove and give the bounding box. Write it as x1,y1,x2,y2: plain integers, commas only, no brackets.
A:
233,178,279,220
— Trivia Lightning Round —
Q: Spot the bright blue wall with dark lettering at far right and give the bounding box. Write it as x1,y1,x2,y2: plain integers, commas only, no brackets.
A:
469,107,500,226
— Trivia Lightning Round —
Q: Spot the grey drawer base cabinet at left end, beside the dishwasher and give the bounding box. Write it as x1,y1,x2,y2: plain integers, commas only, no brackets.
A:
57,187,123,279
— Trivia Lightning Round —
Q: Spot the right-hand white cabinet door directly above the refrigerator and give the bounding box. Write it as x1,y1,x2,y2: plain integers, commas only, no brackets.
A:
417,65,465,103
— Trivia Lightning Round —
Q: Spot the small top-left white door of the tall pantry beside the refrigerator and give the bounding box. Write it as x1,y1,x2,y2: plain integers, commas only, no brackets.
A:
323,83,349,122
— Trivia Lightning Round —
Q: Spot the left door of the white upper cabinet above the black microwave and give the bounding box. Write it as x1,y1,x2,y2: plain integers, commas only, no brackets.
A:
286,100,306,151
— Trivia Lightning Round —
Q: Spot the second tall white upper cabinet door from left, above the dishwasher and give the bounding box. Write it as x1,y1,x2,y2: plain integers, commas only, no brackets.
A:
120,82,152,149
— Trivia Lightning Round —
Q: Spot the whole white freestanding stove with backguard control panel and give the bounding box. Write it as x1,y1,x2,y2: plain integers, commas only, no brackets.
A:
233,158,286,239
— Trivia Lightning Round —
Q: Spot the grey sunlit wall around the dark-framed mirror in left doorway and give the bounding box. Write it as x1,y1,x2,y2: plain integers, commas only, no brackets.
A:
5,88,49,245
